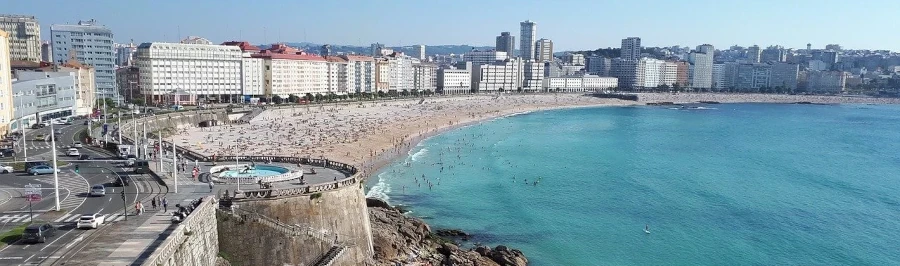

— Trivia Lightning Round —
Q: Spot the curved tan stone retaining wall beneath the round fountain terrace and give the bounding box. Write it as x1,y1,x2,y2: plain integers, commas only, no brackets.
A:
220,184,374,266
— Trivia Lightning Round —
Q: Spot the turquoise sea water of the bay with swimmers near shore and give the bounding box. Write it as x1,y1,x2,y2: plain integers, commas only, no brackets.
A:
369,104,900,265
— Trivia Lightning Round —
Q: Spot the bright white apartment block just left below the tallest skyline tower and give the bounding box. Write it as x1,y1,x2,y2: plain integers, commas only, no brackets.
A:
472,59,520,92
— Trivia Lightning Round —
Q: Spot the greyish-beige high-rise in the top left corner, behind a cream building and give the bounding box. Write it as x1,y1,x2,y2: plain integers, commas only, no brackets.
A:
0,15,41,62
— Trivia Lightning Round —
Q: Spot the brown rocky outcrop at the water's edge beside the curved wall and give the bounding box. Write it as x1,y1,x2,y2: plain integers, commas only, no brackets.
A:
366,199,528,266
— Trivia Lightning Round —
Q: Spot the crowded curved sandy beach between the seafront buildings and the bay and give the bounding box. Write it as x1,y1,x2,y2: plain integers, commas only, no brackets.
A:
176,93,900,178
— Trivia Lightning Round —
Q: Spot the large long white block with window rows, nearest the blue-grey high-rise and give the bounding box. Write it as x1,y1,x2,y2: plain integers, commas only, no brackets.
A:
137,43,242,104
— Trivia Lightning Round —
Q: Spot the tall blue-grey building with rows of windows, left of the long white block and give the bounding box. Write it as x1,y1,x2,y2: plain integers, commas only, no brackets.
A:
50,20,117,98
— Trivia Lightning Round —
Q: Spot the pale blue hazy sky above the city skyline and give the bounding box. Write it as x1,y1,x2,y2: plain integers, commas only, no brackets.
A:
7,0,900,51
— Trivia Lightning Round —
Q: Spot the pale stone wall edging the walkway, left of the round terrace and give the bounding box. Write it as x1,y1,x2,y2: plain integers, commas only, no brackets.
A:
143,197,219,266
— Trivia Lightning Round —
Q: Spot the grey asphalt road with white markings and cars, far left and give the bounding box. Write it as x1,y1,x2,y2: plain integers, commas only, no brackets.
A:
0,120,168,265
